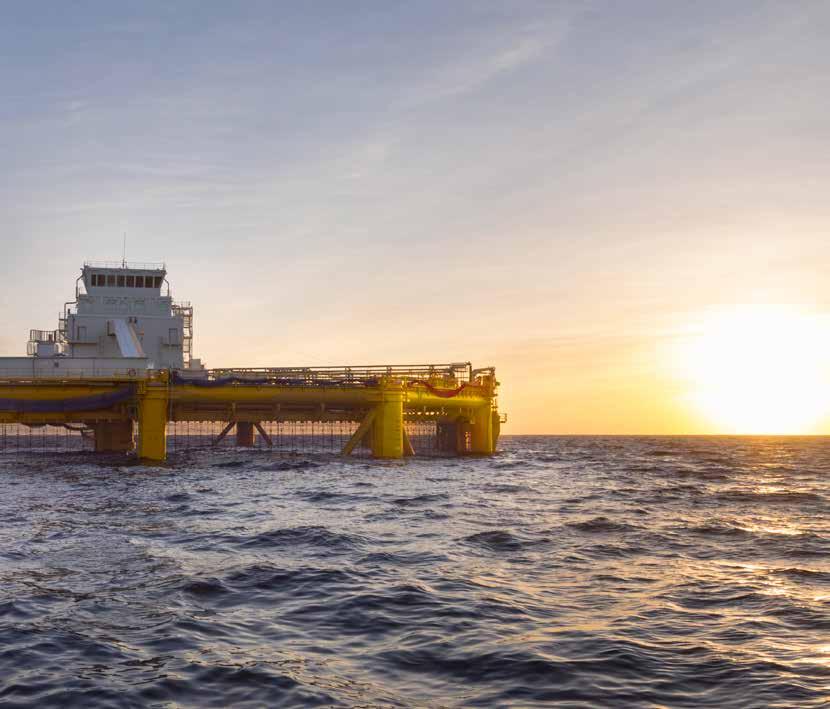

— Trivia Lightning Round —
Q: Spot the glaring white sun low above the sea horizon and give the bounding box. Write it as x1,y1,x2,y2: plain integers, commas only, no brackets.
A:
682,305,830,434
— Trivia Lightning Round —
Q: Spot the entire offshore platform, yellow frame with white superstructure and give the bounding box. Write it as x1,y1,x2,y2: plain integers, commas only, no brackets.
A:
0,261,503,462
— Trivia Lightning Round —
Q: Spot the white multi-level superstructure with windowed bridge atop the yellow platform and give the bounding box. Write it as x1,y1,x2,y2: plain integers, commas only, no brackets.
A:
0,262,201,377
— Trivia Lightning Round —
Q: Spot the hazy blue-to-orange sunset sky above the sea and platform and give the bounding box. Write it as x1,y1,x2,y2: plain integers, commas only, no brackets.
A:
0,0,830,434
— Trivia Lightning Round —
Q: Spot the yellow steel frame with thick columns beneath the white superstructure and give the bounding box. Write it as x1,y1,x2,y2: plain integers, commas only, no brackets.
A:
0,371,500,461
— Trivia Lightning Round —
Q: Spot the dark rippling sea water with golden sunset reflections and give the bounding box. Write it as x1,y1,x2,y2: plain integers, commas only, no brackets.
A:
0,437,830,707
